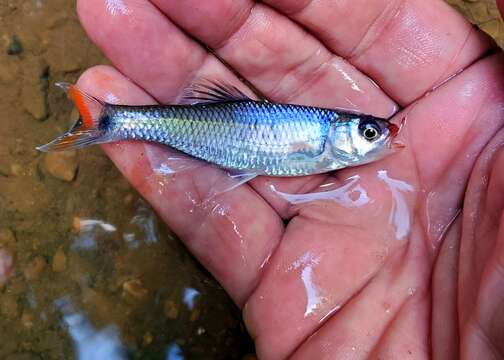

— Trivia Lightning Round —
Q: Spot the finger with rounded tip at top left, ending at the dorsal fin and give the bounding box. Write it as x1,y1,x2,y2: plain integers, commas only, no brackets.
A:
77,0,235,103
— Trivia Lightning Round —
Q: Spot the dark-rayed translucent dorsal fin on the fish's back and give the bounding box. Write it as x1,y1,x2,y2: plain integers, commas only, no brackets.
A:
181,79,253,104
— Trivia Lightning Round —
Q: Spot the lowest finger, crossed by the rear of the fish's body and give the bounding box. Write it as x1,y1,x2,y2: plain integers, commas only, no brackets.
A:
79,67,283,304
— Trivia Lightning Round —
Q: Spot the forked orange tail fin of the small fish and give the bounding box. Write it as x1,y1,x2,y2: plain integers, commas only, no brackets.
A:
37,83,108,152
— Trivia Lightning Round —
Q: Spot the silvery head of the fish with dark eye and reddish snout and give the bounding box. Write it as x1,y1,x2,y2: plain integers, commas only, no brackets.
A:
329,115,404,165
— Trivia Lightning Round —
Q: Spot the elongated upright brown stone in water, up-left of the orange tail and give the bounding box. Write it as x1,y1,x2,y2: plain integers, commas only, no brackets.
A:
21,58,49,121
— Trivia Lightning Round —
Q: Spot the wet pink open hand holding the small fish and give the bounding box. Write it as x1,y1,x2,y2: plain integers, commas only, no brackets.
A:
78,0,504,359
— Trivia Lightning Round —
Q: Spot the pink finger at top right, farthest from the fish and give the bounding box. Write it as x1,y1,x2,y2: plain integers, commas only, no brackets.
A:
266,0,493,105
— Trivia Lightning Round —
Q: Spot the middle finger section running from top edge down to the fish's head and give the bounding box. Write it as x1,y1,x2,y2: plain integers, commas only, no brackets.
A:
152,0,396,117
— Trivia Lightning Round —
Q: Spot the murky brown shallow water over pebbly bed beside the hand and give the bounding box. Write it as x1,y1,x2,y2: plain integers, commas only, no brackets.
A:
0,0,504,359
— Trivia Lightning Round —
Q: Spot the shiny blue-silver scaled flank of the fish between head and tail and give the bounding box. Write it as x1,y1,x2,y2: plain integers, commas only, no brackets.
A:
106,101,330,175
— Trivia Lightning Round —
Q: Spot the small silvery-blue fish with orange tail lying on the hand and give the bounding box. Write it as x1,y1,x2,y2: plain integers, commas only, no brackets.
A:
37,80,403,177
